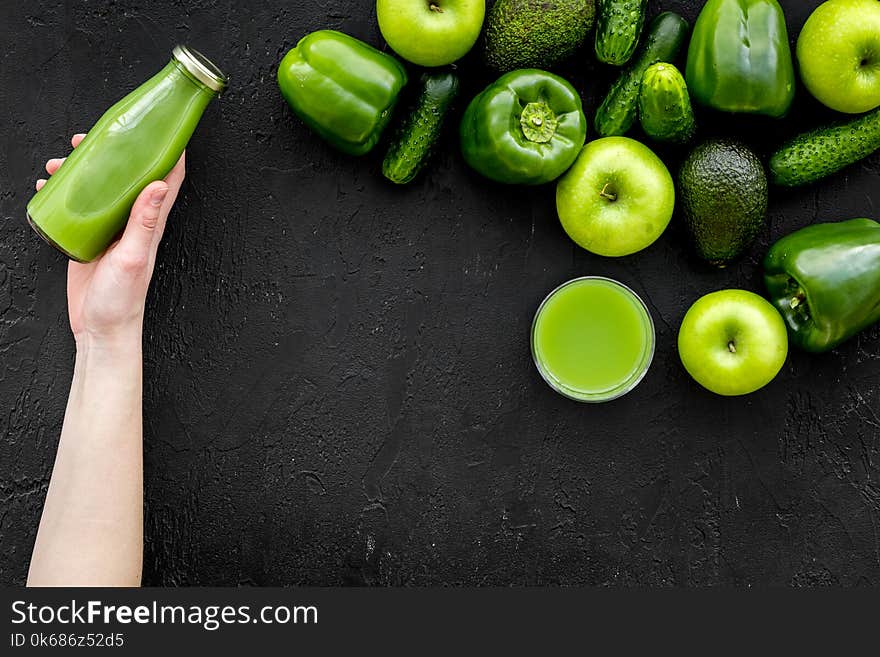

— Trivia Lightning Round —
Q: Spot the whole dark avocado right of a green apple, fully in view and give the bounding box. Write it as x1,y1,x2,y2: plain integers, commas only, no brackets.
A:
678,139,767,267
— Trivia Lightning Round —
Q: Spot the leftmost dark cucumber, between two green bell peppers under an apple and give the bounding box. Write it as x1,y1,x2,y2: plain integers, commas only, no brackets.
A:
382,71,458,185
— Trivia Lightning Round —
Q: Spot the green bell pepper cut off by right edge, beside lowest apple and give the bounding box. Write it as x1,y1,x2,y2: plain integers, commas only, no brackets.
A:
764,219,880,352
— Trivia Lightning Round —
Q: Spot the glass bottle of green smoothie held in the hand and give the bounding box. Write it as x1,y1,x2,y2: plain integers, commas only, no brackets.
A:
27,46,226,262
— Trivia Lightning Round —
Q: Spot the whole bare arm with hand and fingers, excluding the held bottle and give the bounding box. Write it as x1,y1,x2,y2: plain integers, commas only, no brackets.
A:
28,141,186,586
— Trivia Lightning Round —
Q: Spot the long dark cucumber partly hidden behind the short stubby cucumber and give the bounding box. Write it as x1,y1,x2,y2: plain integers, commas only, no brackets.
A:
594,11,690,137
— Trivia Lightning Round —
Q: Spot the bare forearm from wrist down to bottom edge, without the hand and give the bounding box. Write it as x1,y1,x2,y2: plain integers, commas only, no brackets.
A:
28,334,143,586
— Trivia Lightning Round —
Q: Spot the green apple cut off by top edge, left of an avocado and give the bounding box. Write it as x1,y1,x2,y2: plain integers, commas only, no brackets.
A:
376,0,486,66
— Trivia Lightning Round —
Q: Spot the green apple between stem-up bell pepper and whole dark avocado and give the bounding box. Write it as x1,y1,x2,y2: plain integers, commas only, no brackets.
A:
556,137,675,256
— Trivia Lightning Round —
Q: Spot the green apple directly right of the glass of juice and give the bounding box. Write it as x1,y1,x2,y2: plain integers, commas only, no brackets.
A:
678,290,788,395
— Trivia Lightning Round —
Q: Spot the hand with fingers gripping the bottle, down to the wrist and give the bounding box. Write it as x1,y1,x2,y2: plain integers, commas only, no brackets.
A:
37,134,186,346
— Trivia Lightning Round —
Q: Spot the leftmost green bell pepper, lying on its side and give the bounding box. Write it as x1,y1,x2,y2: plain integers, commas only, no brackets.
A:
278,30,406,155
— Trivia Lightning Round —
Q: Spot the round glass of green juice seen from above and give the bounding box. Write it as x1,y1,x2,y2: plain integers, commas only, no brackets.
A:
532,276,654,402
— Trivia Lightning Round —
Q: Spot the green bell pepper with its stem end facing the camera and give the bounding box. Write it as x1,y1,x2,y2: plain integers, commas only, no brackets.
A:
460,68,587,185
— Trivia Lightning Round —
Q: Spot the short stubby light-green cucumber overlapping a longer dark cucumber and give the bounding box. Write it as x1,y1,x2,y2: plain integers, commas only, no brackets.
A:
639,62,697,144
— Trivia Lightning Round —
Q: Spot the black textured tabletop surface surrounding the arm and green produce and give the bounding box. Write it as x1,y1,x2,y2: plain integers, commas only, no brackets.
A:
0,0,880,585
